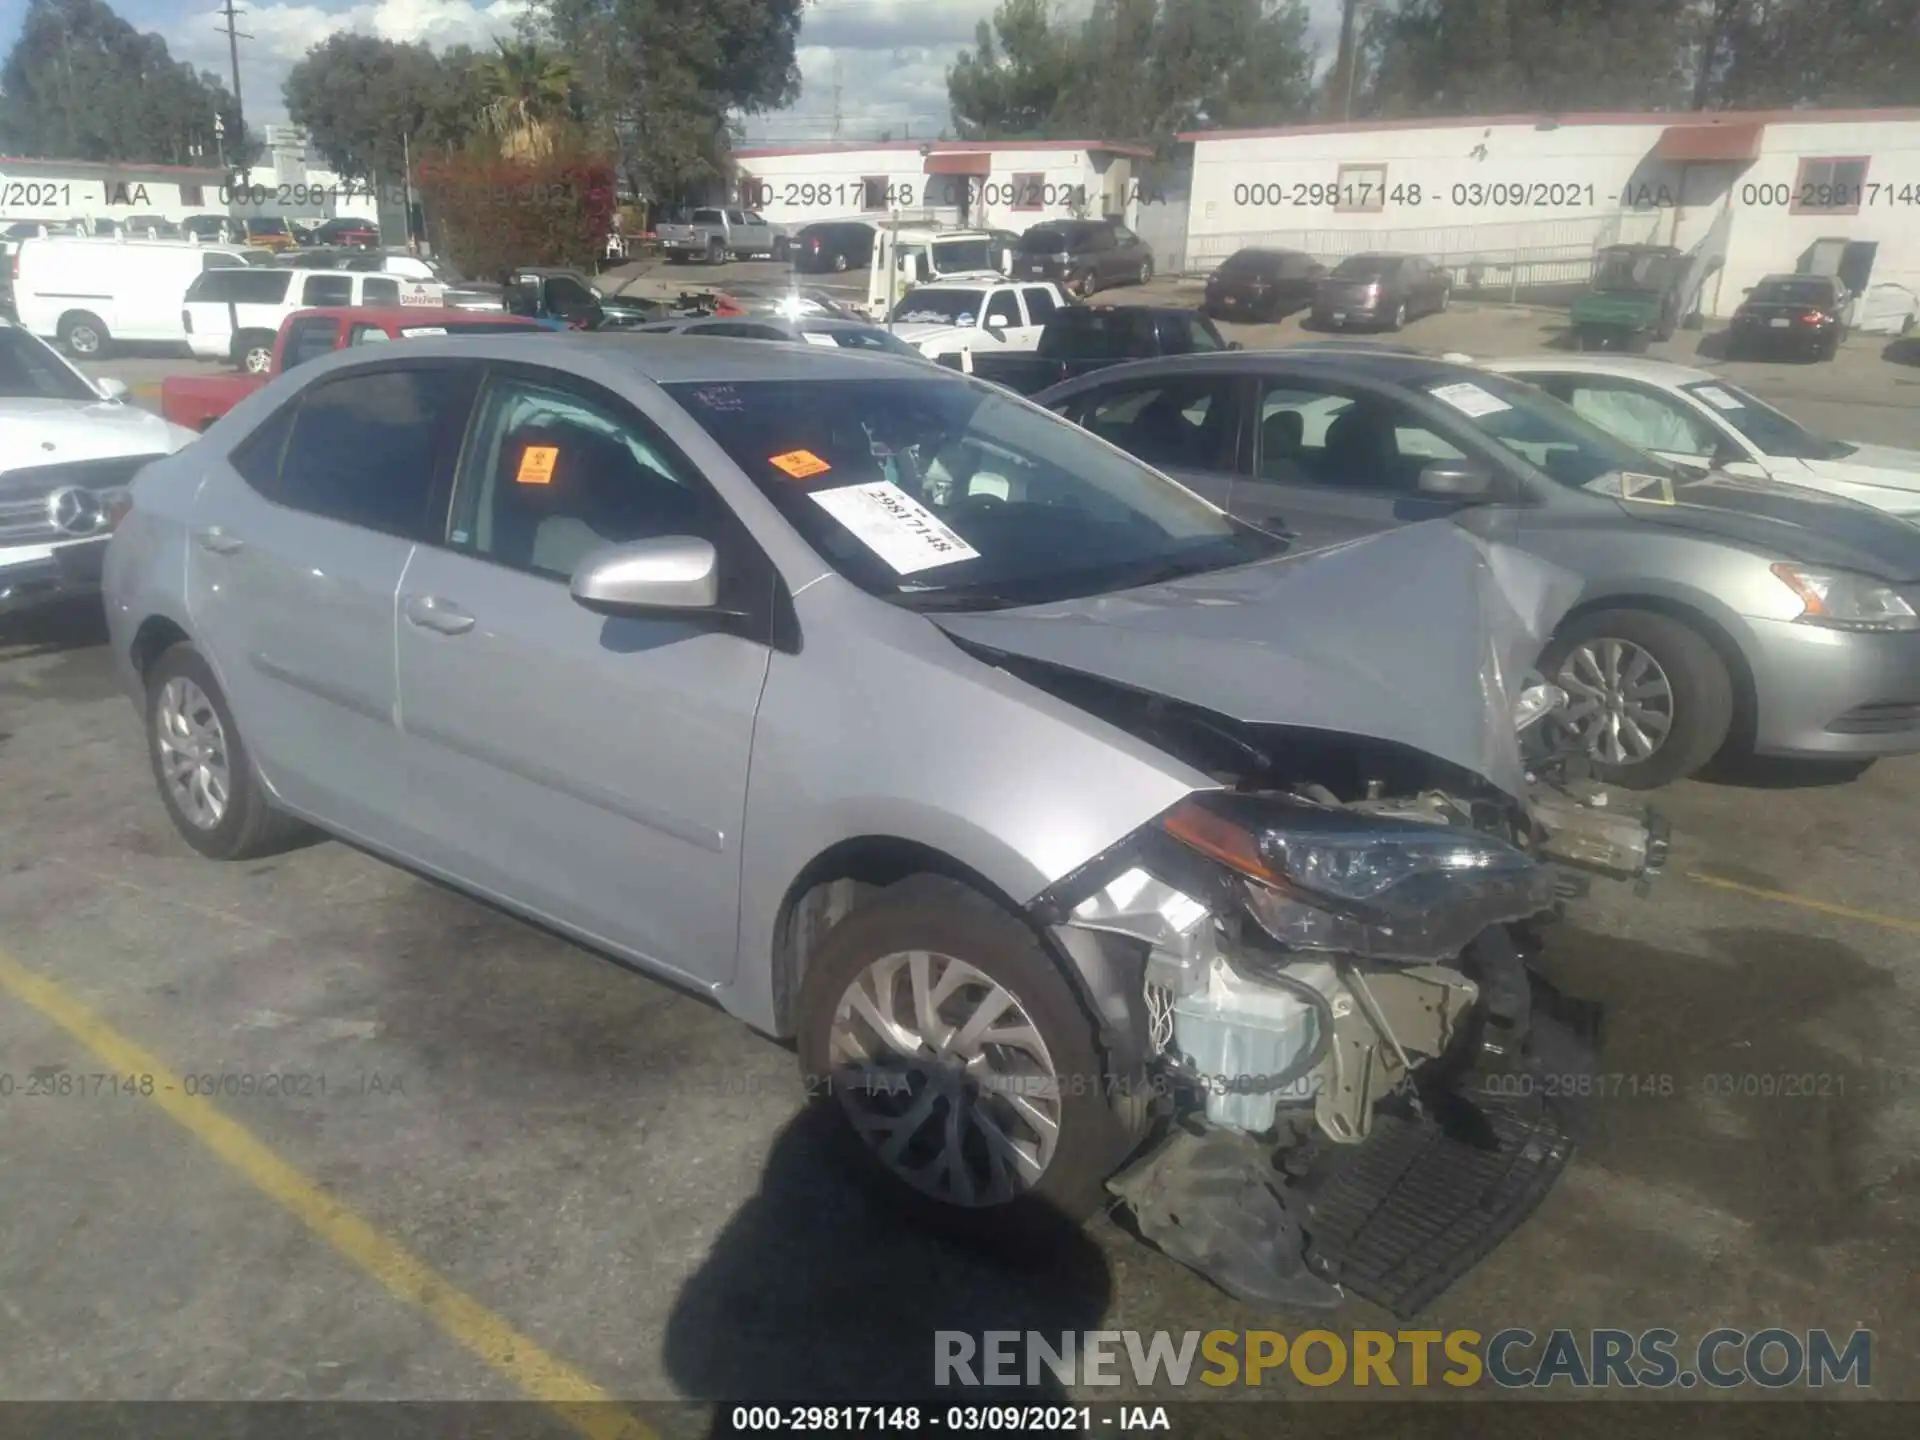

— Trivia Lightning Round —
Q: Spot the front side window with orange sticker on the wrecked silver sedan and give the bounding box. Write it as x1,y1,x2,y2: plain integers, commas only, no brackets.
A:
449,376,716,580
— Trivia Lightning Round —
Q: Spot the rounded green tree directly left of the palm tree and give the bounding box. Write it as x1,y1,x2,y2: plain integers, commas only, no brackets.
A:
284,31,480,182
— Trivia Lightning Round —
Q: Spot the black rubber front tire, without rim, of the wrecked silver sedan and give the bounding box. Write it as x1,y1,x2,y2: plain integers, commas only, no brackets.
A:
797,876,1139,1240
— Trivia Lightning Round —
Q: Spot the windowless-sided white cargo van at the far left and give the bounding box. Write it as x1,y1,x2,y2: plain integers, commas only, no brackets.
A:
12,236,246,359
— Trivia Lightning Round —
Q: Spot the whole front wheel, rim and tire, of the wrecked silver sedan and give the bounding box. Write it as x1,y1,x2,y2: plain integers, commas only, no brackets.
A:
797,876,1131,1238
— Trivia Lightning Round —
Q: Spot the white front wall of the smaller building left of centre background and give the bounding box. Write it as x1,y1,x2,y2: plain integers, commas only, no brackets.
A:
739,144,1133,232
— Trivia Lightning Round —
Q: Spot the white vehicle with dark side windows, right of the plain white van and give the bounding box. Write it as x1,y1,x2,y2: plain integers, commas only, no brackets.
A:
180,265,447,374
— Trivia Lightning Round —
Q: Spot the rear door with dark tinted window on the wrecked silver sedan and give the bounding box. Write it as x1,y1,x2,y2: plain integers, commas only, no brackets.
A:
186,361,470,845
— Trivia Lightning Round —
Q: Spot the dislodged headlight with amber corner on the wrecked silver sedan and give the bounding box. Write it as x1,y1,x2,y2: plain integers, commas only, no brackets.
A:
1162,793,1553,964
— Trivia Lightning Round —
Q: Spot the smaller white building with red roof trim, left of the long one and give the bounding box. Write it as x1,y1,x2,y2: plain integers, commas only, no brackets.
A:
733,140,1154,232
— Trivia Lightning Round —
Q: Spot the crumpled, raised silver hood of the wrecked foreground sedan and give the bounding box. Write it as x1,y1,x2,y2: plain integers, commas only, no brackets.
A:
927,520,1580,799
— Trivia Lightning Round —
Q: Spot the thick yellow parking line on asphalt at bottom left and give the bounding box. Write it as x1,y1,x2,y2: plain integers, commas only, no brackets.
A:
0,950,657,1440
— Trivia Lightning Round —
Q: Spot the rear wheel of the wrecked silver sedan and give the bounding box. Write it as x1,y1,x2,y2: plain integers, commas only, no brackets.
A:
146,645,305,860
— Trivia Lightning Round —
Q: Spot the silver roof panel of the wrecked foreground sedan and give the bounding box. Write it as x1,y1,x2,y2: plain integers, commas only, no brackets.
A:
320,326,929,384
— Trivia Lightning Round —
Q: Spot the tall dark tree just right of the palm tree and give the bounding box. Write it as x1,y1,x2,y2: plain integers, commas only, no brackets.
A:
534,0,804,204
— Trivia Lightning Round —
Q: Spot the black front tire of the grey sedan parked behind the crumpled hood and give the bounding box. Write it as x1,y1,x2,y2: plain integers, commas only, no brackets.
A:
1540,611,1734,789
